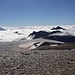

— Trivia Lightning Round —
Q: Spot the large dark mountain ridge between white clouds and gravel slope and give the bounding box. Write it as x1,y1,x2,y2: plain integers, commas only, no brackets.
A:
29,30,75,42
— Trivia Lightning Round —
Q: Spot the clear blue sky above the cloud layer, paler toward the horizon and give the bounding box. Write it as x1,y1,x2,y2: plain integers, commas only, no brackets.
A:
0,0,75,26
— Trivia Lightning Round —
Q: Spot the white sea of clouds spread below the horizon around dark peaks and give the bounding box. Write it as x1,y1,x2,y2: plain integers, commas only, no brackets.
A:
0,25,75,42
